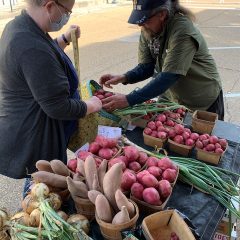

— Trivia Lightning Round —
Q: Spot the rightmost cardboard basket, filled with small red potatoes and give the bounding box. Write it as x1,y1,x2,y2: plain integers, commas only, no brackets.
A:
195,147,227,165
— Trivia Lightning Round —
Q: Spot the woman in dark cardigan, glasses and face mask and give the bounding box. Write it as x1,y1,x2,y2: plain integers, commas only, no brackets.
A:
0,0,102,178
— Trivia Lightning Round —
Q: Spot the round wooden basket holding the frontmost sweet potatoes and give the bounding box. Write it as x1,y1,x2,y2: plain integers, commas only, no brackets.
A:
96,199,139,240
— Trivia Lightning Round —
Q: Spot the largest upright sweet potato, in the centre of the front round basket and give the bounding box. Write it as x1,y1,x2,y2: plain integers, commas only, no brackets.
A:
103,163,122,211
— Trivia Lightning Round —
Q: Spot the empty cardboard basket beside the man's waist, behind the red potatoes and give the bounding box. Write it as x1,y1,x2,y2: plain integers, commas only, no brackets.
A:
192,110,218,134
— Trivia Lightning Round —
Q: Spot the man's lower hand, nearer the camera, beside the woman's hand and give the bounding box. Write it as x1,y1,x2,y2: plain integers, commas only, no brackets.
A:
102,93,129,112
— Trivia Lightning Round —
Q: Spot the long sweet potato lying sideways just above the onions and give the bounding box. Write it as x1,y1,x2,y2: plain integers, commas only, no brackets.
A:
31,171,67,188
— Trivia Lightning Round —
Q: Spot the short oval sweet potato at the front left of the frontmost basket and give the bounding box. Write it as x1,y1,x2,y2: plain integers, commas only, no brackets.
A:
95,194,112,223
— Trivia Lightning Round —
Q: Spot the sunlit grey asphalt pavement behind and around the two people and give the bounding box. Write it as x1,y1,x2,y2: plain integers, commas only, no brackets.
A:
0,0,240,235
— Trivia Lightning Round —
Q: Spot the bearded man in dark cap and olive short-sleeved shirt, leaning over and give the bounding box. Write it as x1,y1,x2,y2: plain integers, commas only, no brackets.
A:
100,0,224,120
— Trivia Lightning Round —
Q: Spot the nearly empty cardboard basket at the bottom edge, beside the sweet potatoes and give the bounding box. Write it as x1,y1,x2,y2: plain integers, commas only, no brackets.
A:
142,210,195,240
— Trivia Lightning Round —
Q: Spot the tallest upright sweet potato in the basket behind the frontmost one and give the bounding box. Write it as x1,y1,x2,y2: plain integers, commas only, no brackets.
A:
84,156,97,190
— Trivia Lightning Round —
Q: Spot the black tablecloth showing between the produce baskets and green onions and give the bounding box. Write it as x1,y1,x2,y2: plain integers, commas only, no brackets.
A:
86,125,240,240
